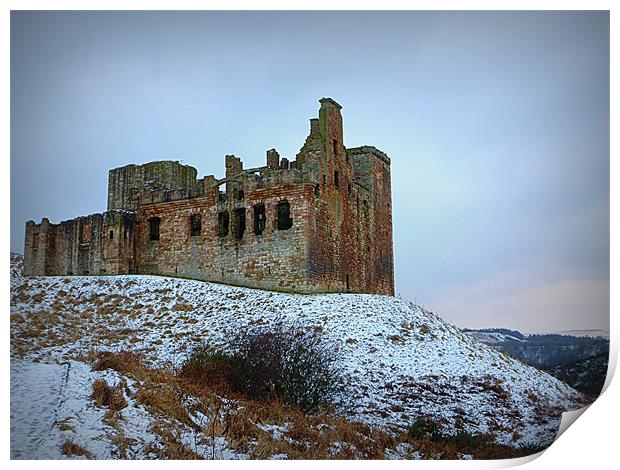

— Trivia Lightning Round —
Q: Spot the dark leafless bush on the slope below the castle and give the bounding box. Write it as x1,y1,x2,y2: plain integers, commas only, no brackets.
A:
180,327,340,412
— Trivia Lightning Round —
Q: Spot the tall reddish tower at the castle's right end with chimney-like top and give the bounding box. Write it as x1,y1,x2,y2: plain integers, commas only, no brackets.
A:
306,99,394,295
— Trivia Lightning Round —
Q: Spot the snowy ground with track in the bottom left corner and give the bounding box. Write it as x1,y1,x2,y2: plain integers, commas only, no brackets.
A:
11,358,247,459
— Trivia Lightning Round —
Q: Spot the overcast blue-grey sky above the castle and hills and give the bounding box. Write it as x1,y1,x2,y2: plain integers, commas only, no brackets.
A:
11,12,609,332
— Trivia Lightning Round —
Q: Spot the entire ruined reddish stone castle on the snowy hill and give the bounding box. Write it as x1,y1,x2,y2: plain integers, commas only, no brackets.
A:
24,98,394,295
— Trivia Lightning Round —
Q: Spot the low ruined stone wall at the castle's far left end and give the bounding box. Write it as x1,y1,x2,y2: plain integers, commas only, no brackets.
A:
24,211,135,276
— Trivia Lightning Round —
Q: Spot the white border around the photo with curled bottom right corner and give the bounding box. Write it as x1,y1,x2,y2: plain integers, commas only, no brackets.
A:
0,0,620,469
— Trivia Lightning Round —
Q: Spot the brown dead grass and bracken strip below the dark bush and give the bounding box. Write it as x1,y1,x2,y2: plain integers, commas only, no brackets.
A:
86,352,539,459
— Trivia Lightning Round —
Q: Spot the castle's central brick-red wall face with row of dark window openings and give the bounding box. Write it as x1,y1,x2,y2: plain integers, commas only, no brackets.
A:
136,185,316,292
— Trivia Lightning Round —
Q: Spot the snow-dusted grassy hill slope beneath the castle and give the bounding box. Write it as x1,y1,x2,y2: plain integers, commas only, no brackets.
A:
11,253,584,456
